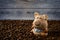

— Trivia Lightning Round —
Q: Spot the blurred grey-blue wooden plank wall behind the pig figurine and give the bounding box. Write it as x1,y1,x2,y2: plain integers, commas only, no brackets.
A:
0,0,60,20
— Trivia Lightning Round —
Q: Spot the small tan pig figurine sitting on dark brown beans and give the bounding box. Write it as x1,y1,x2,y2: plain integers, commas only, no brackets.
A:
31,12,48,36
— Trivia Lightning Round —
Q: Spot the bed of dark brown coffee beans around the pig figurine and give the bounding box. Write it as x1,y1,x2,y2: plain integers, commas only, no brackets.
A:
0,20,60,40
